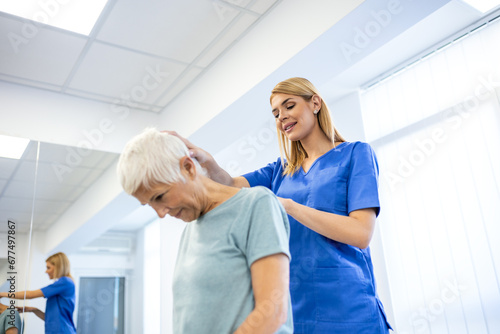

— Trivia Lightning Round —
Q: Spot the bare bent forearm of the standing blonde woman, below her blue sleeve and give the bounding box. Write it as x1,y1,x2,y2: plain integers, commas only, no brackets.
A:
280,198,376,249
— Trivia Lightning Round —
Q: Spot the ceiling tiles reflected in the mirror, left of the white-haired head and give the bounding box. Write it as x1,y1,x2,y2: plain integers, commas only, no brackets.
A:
0,141,118,233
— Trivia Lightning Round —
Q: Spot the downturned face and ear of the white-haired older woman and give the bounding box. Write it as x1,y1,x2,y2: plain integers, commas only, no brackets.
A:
132,159,207,222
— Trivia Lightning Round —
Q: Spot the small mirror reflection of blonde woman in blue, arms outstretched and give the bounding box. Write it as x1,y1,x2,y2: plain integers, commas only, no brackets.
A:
0,252,76,334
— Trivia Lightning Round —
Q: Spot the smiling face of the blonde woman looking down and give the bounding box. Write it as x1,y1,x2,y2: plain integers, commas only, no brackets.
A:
271,94,317,141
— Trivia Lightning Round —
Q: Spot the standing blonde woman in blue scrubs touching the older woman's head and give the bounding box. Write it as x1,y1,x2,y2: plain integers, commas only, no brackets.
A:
170,78,390,334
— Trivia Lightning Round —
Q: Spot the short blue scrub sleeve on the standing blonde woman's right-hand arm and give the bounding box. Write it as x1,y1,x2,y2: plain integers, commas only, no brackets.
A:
347,142,380,216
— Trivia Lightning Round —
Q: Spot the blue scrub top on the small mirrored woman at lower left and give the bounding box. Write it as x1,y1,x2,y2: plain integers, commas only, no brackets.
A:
41,276,76,334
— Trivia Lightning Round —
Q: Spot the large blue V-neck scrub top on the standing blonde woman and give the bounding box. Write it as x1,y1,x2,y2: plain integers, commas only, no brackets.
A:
243,142,390,334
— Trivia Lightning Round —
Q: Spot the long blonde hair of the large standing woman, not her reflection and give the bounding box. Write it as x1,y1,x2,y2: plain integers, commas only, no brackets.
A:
269,78,345,175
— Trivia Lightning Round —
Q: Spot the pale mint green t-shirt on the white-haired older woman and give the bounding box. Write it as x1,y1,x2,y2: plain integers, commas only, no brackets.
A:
173,187,293,334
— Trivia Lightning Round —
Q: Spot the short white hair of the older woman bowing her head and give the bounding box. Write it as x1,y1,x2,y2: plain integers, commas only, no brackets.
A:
117,128,203,195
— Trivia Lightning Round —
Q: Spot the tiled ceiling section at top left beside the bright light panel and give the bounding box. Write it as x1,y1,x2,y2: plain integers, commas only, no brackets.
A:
0,0,281,113
